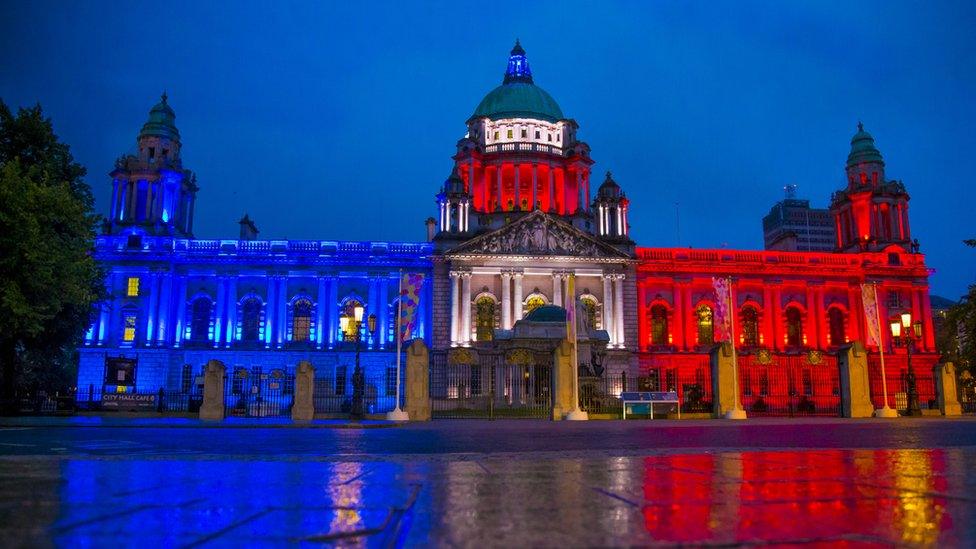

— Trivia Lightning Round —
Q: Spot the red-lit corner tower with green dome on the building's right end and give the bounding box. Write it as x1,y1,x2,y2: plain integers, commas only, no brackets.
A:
830,123,912,252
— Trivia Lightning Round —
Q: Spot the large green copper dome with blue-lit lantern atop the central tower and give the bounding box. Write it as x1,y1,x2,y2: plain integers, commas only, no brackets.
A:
471,40,564,122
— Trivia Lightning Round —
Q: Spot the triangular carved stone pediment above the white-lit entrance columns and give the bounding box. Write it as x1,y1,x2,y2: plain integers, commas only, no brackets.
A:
447,210,630,259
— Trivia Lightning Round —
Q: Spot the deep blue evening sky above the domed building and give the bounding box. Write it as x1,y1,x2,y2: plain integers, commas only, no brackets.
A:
0,0,976,297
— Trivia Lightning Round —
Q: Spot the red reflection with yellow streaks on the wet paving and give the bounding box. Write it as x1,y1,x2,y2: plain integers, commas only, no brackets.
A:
642,450,952,545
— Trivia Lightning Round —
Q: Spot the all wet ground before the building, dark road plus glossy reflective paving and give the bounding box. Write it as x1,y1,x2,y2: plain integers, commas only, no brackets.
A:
0,418,976,547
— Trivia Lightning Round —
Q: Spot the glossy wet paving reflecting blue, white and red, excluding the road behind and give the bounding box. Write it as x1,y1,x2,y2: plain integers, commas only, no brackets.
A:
0,448,976,547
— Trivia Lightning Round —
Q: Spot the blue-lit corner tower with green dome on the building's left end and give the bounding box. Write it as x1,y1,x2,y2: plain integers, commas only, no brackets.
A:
106,93,199,238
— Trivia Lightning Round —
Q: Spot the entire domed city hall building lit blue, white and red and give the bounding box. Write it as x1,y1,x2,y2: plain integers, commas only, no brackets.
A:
77,43,938,417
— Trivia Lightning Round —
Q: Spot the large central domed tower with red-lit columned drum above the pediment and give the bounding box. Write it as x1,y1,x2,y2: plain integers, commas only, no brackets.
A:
435,41,594,242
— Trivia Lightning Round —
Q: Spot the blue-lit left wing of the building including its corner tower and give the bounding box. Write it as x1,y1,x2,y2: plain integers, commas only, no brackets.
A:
78,96,432,400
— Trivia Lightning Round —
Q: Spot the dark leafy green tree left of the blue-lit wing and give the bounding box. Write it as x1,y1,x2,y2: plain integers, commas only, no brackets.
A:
0,100,104,410
